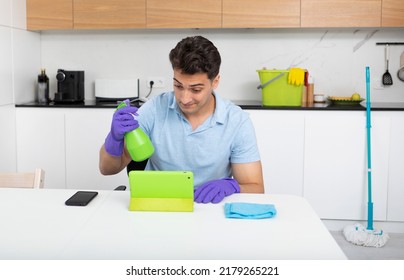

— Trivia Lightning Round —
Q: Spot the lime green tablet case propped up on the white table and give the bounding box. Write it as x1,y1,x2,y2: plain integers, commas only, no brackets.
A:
129,170,194,212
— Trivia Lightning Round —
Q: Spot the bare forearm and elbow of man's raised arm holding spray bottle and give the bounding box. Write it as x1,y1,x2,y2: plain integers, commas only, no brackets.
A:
99,145,132,175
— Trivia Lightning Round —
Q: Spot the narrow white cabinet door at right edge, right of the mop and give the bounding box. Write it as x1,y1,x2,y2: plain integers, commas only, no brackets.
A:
387,112,404,222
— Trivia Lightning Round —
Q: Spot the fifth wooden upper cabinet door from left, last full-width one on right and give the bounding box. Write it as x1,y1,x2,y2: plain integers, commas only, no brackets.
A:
301,0,382,27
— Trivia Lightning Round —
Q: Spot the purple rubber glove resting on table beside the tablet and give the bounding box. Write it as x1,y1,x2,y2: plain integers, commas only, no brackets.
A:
194,178,240,203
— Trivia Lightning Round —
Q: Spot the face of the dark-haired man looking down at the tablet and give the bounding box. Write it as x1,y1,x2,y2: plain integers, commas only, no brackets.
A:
173,70,219,116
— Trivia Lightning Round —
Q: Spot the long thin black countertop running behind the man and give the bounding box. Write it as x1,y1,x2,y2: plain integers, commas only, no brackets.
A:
15,100,404,111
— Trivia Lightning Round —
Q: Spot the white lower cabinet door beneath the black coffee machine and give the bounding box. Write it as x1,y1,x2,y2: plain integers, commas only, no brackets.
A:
16,108,66,188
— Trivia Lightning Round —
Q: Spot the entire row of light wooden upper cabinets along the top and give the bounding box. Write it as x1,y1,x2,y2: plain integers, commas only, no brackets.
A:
26,0,404,30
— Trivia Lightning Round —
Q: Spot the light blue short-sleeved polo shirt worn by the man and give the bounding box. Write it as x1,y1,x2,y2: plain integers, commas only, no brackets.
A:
137,92,260,187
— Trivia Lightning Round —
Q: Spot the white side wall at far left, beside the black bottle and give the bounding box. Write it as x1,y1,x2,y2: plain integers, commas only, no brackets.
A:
0,0,40,172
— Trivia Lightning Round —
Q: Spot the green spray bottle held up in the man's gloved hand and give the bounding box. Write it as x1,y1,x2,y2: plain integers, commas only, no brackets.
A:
117,102,154,162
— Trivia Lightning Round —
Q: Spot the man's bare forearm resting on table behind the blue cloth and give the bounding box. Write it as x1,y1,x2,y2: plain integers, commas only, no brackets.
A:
231,161,264,193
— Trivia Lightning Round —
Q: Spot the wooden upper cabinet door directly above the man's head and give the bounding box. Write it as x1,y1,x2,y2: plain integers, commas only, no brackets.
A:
146,0,222,28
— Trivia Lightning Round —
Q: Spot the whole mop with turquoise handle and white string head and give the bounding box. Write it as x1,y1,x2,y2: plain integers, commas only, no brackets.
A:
343,67,389,247
